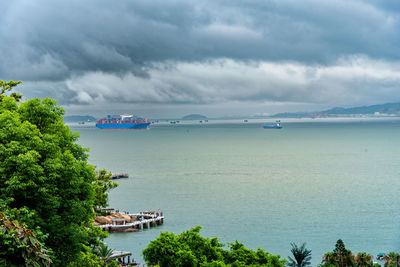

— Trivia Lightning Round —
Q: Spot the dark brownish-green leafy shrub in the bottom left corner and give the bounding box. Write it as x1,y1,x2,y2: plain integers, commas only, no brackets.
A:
0,211,52,266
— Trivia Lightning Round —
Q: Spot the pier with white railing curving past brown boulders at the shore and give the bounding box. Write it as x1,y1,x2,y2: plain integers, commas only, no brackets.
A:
99,211,164,232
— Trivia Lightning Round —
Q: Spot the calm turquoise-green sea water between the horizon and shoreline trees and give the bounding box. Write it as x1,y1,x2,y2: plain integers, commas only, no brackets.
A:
72,120,400,265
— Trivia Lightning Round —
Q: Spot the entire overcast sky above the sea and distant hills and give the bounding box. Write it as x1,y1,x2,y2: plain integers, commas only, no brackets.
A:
0,0,400,118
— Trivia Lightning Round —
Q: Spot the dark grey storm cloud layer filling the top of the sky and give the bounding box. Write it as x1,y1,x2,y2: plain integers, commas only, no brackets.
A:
0,0,400,80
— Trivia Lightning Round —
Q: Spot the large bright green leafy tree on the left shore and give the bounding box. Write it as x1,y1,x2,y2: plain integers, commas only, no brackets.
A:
0,81,111,266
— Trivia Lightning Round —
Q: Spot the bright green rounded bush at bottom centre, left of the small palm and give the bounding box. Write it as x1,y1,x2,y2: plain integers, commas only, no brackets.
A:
143,226,286,267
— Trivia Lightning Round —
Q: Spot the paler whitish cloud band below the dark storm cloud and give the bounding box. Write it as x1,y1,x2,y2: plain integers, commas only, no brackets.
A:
31,56,400,109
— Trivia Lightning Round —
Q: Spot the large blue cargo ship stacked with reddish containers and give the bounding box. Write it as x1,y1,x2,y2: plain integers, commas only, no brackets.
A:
96,114,151,129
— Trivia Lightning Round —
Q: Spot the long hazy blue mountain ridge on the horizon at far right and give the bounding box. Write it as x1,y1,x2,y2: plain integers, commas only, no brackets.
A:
272,103,400,118
